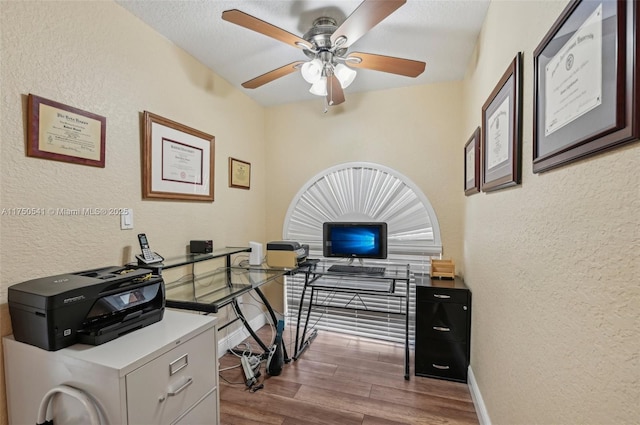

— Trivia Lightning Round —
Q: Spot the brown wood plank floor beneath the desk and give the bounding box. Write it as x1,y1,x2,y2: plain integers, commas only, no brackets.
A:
220,327,478,425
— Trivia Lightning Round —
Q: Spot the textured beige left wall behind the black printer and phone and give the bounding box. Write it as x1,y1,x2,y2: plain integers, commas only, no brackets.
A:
0,1,266,423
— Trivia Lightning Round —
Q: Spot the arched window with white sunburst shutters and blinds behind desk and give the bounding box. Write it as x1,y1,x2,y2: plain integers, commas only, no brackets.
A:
283,162,442,341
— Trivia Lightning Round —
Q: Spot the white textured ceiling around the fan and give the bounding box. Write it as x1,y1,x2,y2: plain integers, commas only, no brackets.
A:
116,0,490,106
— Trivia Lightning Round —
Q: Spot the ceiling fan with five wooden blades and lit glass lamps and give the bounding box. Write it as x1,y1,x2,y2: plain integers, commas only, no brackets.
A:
222,0,426,106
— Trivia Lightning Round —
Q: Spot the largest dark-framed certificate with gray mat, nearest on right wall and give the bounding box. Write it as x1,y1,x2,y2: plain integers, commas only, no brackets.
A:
533,0,640,173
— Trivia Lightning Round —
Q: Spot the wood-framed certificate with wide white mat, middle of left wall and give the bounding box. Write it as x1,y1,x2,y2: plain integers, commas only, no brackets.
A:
142,111,215,202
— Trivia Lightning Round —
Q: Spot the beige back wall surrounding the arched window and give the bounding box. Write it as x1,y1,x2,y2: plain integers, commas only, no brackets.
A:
266,83,465,310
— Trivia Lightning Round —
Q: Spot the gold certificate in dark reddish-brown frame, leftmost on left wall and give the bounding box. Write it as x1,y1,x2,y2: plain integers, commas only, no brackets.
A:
27,94,107,168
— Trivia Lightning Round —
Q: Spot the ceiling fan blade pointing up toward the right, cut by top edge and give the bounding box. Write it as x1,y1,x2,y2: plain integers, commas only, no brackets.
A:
331,0,407,47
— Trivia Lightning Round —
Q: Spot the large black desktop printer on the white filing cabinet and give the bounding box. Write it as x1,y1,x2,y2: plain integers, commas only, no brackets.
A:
8,267,165,351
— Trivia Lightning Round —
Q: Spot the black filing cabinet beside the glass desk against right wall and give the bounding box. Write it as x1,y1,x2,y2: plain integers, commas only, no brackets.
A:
415,277,471,382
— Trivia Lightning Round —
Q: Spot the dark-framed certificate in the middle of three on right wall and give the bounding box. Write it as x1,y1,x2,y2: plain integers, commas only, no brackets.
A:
480,52,522,192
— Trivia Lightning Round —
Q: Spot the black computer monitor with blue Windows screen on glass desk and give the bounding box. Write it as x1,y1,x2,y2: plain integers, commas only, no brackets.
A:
322,221,387,259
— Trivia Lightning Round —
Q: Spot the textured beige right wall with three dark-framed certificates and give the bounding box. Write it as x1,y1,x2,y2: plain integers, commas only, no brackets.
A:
463,1,640,424
